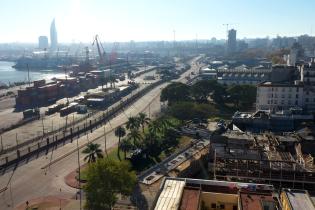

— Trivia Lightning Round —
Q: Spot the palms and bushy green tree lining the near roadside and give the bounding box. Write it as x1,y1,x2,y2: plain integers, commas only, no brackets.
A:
83,113,179,210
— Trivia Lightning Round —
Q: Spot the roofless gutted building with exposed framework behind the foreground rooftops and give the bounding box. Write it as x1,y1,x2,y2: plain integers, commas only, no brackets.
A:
208,128,315,193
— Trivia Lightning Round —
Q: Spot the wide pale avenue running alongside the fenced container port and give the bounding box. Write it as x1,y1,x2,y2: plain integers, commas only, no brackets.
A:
0,55,199,210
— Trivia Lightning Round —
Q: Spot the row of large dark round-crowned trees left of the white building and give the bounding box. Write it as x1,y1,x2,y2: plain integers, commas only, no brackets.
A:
160,80,256,109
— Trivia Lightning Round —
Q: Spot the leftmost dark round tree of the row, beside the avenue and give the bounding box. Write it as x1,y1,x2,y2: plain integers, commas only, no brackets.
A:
160,82,190,105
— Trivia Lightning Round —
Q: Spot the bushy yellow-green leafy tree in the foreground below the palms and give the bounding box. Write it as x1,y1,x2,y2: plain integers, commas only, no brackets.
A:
84,158,136,210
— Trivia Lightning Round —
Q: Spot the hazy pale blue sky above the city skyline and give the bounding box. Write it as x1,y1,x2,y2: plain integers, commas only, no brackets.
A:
0,0,315,42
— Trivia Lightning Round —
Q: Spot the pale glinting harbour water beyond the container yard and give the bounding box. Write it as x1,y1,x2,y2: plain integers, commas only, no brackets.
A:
0,61,64,84
